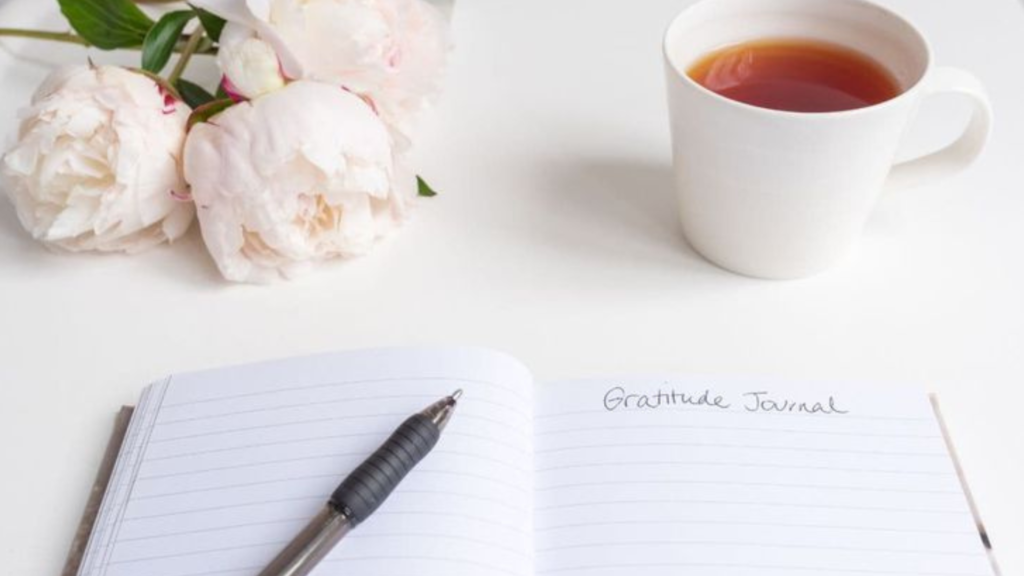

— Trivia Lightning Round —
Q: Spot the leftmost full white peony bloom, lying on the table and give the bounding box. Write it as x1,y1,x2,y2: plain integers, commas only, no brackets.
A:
0,66,194,252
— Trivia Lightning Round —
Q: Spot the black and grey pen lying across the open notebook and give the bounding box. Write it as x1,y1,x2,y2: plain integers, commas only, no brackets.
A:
259,389,462,576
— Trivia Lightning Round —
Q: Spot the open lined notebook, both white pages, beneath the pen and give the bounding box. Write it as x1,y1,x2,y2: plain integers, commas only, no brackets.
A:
72,349,994,576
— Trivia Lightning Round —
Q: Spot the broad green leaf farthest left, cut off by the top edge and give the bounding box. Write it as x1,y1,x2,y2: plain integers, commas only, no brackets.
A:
57,0,153,50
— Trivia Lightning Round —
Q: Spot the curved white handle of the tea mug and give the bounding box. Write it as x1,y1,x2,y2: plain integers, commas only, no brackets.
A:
888,68,992,189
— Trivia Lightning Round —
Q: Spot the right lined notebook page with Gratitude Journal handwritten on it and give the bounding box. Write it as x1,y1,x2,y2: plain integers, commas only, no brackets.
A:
535,379,992,576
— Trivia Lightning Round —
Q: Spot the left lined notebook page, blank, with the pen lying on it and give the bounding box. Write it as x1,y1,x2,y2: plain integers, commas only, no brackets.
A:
80,349,532,576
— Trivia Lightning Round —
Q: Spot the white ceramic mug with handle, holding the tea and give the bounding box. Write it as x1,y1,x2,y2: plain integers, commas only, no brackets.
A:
665,0,991,279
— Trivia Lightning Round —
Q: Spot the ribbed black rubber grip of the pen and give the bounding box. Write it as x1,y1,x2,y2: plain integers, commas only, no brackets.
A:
331,414,440,526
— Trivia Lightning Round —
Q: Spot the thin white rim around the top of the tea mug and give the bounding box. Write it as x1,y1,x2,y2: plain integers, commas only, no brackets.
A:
662,0,932,119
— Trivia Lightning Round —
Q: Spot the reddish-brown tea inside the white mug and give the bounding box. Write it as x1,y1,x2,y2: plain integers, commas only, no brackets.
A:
688,39,901,112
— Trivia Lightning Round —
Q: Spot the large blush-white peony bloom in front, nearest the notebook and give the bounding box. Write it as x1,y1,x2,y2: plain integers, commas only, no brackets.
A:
184,81,414,282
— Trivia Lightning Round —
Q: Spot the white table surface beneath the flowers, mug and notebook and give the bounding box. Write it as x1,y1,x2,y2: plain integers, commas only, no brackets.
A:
0,0,1024,576
